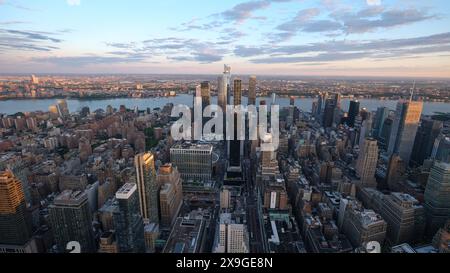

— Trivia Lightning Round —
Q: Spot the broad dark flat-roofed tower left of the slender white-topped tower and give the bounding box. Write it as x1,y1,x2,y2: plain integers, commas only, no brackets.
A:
49,190,97,253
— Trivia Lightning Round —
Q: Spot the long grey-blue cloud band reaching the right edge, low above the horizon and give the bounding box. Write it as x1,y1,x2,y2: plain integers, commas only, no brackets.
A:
248,32,450,63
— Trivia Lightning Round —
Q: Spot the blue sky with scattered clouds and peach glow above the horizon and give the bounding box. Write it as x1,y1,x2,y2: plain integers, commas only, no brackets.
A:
0,0,450,78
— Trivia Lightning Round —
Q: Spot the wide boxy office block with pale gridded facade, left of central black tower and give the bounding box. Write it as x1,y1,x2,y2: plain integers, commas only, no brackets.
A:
170,143,213,183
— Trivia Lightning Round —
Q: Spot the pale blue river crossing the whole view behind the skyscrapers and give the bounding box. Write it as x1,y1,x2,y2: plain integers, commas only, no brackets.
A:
0,94,450,115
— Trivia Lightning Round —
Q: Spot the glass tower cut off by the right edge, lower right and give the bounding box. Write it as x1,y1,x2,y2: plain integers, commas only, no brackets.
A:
424,161,450,237
